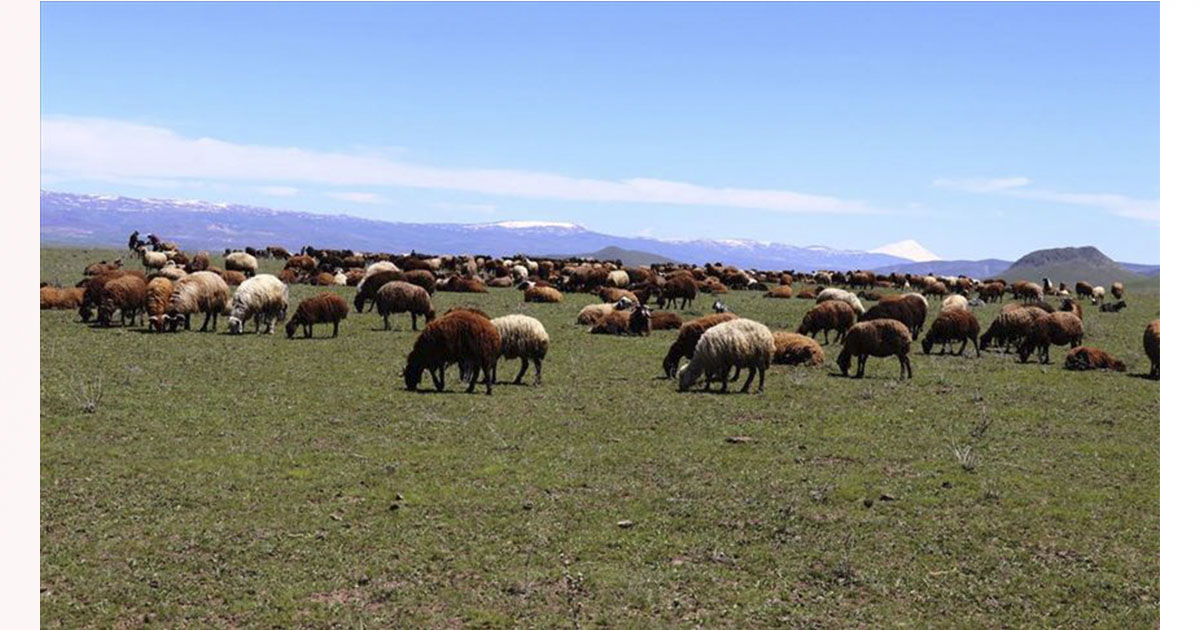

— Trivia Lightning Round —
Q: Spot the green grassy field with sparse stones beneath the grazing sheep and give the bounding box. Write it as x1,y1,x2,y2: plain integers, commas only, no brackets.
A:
41,250,1159,628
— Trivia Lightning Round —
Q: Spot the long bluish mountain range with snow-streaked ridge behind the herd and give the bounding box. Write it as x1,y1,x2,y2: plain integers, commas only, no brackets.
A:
41,191,910,271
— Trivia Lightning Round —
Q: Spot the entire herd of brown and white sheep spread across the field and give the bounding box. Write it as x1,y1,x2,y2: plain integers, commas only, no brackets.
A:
41,225,1159,394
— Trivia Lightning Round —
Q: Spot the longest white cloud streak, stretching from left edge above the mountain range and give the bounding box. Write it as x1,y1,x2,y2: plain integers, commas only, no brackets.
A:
42,116,880,214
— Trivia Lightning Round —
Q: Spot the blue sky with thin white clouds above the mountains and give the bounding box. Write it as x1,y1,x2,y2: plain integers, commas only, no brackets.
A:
41,2,1159,263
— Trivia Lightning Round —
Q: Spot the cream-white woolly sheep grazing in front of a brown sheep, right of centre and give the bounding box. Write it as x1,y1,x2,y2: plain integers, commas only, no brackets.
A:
679,318,775,394
